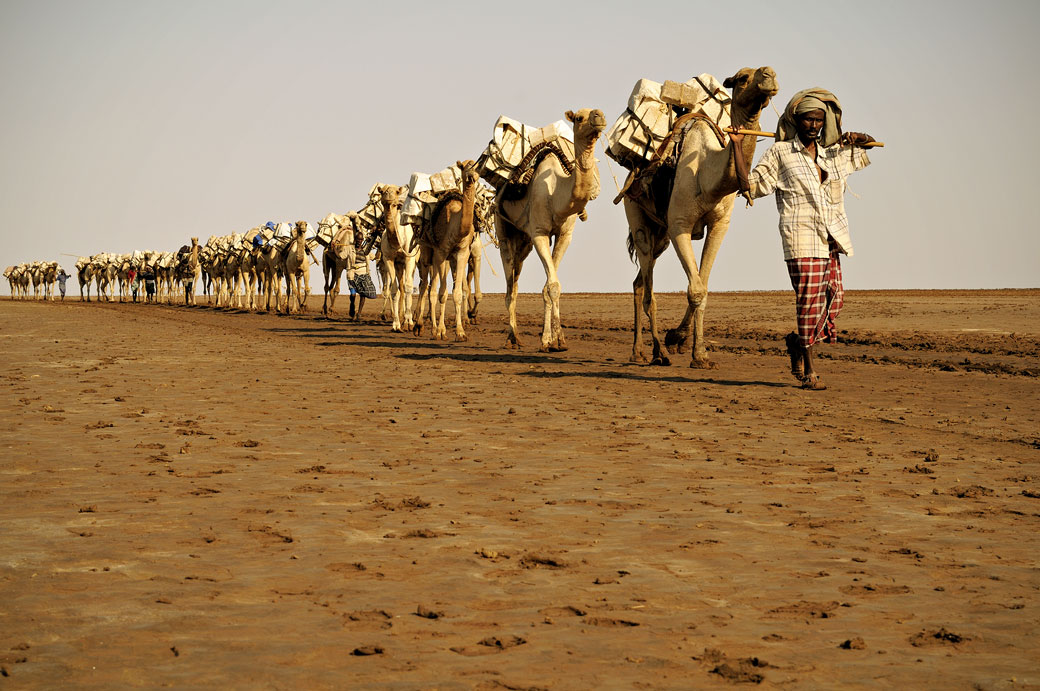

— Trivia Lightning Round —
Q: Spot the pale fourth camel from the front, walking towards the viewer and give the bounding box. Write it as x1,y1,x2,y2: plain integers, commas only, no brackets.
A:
380,185,419,332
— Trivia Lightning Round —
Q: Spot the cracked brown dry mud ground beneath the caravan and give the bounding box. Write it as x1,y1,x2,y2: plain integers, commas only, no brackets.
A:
0,290,1040,689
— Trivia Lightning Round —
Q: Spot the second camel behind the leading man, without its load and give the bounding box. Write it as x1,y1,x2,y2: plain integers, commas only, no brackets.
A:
495,108,606,352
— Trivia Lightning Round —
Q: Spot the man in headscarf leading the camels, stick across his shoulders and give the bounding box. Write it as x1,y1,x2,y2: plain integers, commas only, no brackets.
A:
730,88,874,391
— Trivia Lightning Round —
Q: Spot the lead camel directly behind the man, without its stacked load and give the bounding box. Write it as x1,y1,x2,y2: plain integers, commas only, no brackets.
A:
625,67,779,368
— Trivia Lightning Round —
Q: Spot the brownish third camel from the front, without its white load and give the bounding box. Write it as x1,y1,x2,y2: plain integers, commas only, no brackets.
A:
414,160,480,342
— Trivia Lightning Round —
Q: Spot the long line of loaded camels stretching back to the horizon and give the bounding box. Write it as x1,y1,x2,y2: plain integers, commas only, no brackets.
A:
10,67,819,366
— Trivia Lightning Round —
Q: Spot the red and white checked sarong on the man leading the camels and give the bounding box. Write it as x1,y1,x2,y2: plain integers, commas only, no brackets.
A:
787,242,844,348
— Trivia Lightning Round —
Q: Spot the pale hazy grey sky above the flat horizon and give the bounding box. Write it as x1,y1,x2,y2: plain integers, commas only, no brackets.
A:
0,0,1040,293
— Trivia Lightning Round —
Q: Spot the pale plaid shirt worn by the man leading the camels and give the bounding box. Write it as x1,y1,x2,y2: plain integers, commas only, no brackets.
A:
748,137,870,259
